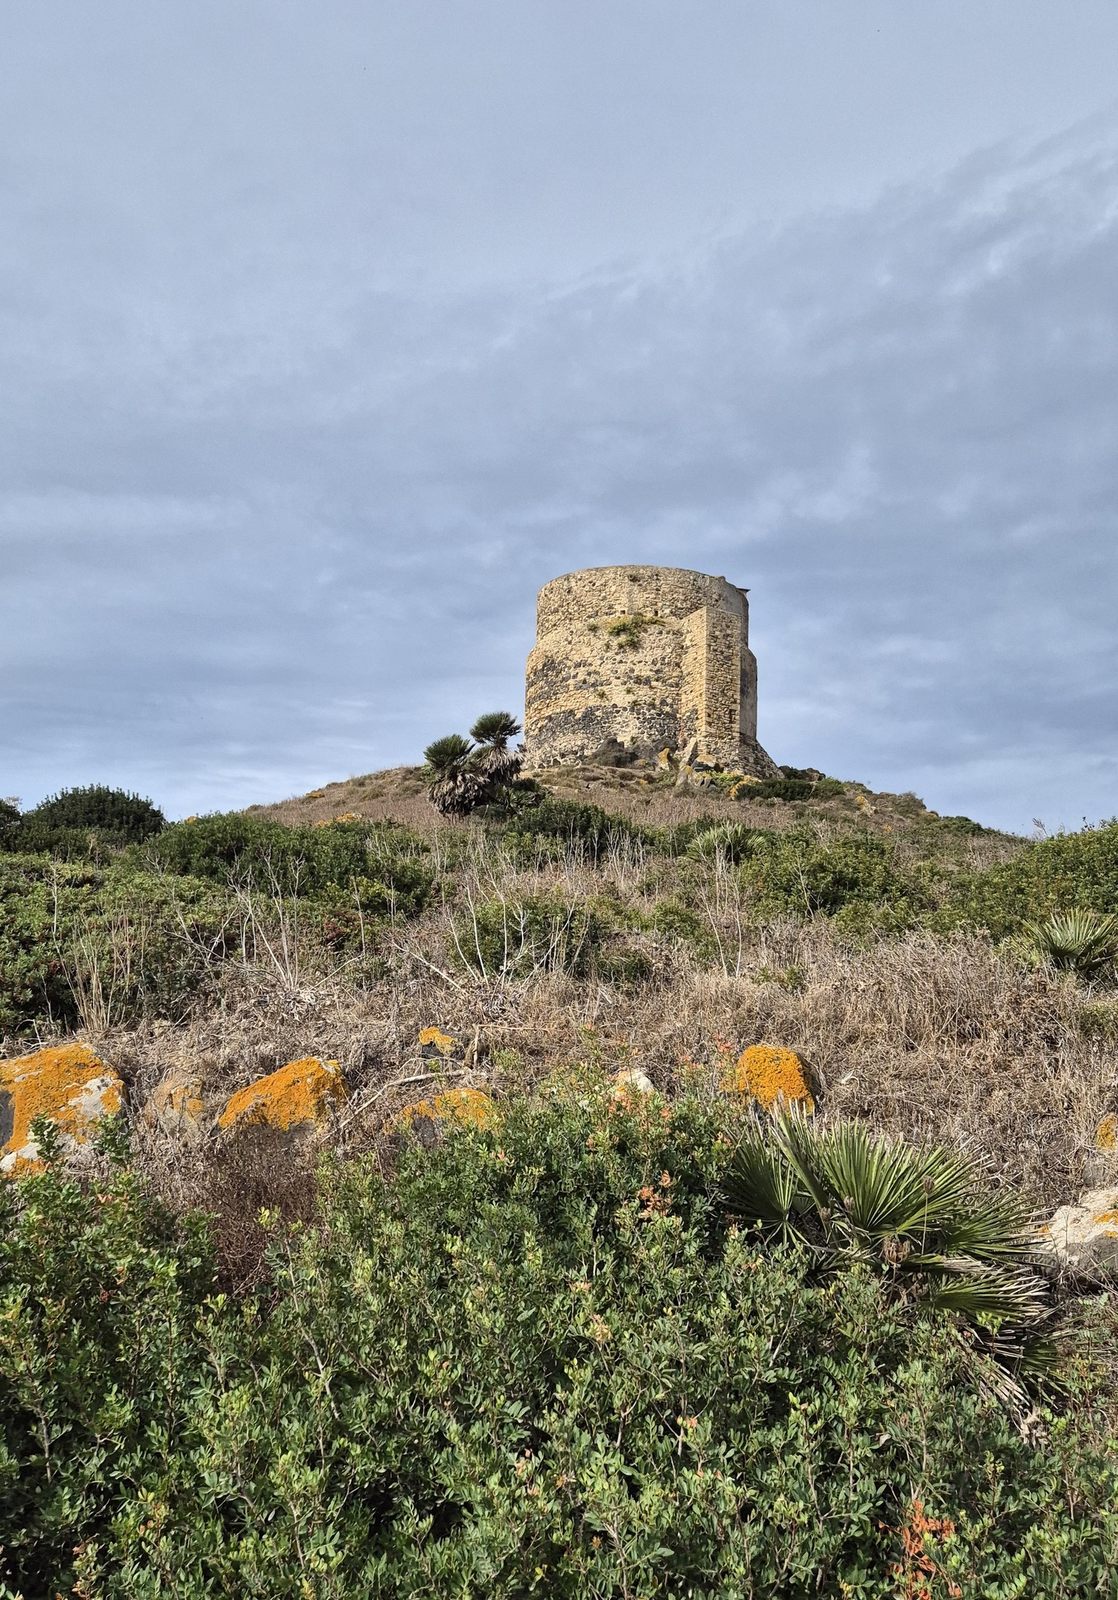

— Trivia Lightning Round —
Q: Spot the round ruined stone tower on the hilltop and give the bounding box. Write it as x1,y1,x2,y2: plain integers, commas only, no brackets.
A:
525,566,777,778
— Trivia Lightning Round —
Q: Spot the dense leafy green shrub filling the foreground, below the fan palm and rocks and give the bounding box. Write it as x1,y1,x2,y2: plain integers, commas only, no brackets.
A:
0,1091,1118,1600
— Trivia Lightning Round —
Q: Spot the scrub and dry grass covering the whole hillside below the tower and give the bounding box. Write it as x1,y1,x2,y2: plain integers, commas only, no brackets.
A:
0,774,1118,1600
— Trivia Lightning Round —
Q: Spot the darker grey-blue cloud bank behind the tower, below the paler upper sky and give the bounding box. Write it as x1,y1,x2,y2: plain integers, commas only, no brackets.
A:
0,112,1118,827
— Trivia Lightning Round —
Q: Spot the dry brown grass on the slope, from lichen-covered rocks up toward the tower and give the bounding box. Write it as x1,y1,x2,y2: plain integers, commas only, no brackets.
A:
19,768,1118,1248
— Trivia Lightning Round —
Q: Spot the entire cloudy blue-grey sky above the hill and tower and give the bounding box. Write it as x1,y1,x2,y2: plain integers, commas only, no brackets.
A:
0,9,1118,830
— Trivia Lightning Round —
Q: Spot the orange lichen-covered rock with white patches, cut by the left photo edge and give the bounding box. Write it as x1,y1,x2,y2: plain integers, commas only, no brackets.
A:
0,1045,125,1174
